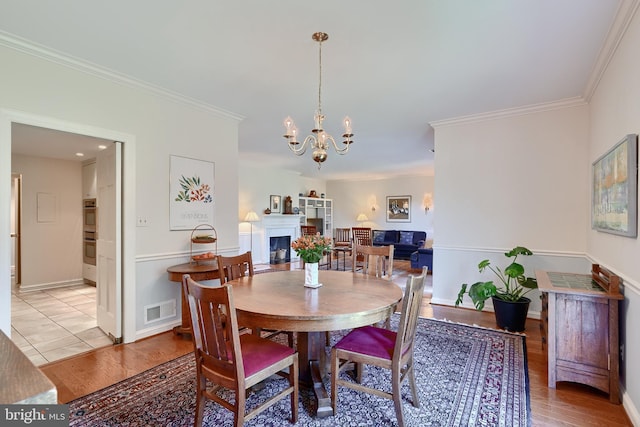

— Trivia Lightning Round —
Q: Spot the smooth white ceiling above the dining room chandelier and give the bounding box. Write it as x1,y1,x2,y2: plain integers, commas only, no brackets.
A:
0,0,633,179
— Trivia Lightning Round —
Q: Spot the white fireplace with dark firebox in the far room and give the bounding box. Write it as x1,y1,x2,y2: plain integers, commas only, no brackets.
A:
262,215,300,264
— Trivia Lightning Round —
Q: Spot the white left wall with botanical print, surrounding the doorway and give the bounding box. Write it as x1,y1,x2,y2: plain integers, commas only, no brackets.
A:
0,40,239,340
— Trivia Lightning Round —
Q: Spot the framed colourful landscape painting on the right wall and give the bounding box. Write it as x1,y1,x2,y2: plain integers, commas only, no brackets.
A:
591,134,638,237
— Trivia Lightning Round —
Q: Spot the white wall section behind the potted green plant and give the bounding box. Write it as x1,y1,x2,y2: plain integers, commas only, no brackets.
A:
433,103,589,317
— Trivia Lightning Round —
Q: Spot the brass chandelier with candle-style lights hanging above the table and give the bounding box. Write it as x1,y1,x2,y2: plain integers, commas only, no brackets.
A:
284,33,353,169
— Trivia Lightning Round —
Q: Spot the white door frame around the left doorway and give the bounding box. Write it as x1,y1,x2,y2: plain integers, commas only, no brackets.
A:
0,109,136,342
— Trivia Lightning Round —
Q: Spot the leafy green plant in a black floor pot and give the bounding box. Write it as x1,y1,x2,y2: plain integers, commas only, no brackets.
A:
456,246,538,332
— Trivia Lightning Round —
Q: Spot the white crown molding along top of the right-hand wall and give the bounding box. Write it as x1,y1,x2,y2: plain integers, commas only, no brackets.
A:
583,0,640,102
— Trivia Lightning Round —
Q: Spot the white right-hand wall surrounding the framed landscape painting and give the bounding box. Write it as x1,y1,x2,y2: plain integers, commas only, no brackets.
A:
586,5,640,425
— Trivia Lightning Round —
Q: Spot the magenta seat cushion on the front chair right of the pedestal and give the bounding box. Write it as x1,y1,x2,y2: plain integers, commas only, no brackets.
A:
335,326,397,360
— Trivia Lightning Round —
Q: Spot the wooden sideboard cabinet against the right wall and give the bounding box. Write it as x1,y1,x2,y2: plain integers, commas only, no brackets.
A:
536,264,624,403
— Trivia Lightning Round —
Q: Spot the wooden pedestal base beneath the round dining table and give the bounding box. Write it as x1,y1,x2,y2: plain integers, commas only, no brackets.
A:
297,332,333,418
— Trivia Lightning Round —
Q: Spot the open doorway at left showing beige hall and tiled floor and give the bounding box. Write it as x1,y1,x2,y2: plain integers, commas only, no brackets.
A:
11,123,121,365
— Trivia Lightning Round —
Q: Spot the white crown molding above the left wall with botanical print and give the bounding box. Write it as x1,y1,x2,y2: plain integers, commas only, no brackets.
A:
0,31,244,121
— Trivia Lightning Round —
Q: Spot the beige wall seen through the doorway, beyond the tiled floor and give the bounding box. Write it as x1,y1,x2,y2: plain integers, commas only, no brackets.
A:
11,155,83,289
